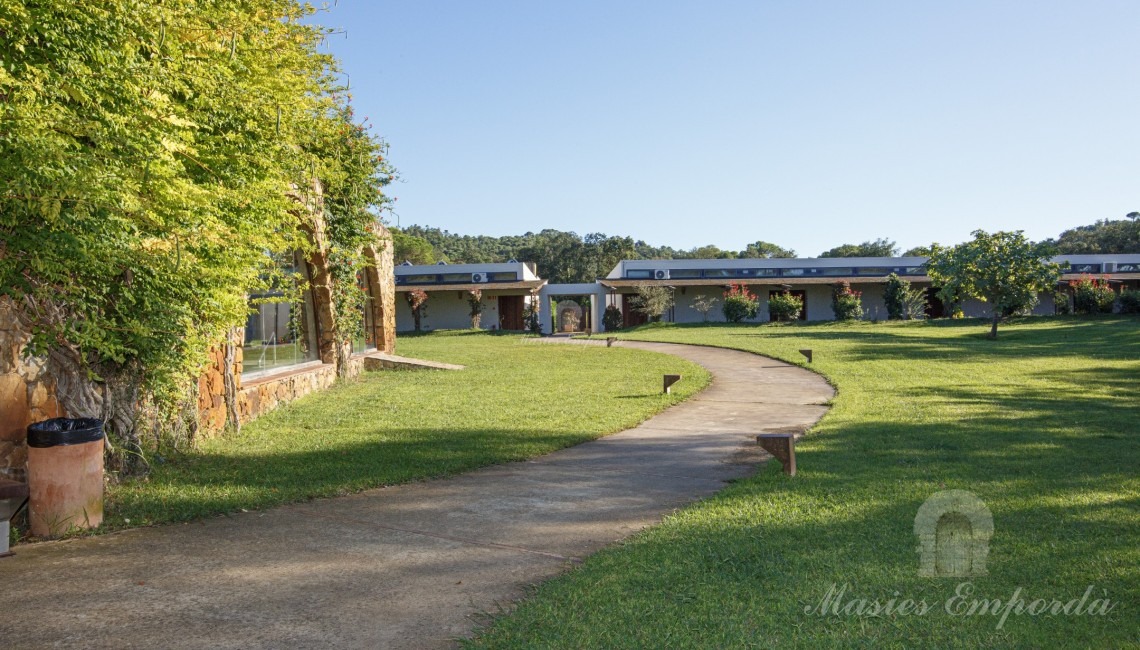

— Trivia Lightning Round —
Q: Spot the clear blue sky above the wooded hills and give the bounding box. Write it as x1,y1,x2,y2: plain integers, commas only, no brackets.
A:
318,0,1140,257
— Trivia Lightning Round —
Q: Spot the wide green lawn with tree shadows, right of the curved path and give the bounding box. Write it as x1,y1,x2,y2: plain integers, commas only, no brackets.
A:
470,317,1140,649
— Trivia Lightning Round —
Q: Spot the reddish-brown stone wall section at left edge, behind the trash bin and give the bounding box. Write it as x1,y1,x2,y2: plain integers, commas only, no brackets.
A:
0,298,63,480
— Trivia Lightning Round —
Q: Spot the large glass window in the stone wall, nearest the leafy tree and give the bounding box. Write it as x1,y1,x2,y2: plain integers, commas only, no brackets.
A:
242,250,318,379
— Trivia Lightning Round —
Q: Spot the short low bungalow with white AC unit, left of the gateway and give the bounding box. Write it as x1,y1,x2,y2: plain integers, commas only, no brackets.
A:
396,260,546,332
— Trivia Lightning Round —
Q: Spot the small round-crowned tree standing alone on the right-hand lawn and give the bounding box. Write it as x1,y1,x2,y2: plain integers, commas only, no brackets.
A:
927,230,1061,339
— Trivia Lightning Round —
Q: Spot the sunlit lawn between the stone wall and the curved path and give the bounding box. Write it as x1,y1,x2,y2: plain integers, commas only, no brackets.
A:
100,332,708,530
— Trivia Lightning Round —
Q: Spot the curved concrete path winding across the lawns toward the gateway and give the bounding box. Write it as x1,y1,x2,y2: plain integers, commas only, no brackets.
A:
0,342,832,649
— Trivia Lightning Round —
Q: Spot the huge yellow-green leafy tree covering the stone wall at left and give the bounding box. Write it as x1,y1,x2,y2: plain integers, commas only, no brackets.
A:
0,0,393,469
